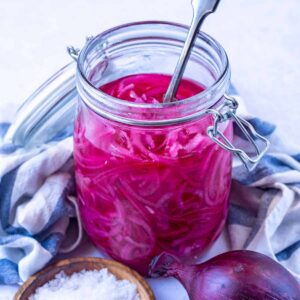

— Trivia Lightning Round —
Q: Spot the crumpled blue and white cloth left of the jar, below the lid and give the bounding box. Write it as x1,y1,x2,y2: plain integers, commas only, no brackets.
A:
0,130,76,284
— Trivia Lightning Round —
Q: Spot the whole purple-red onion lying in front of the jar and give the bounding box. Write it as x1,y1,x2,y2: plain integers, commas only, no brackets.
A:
150,250,300,300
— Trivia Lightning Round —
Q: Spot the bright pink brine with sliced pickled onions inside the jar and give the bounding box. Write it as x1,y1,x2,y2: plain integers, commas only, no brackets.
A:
74,74,232,273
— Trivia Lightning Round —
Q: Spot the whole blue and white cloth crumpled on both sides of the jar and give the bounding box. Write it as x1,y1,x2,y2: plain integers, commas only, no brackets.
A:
0,88,300,284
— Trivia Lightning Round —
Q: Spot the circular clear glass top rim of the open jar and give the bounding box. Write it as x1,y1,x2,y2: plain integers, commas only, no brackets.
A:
77,21,230,109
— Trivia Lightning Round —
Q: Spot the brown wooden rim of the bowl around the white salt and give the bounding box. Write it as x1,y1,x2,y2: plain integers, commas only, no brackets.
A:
14,257,155,300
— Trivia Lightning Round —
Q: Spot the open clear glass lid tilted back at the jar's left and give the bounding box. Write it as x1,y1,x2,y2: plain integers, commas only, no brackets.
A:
4,62,77,148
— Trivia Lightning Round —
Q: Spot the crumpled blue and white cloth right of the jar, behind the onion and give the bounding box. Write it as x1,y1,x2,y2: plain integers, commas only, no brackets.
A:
227,103,300,283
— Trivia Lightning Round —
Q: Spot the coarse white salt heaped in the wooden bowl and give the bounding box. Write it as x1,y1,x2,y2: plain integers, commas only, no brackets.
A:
29,269,140,300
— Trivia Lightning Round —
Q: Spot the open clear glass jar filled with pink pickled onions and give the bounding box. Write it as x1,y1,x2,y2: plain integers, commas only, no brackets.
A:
74,22,233,273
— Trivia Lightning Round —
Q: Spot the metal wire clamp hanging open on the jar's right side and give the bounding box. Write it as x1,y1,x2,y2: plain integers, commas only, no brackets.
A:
207,95,270,171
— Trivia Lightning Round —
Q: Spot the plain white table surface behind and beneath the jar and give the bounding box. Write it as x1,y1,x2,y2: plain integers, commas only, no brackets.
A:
0,0,300,300
